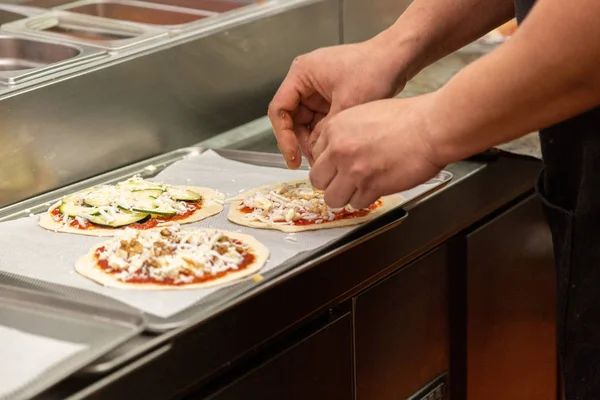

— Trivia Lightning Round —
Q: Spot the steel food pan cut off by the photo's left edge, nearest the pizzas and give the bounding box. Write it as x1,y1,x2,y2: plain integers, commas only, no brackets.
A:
0,33,108,85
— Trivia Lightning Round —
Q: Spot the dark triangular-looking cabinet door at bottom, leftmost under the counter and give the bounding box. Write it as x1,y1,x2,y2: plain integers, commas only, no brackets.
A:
206,313,353,400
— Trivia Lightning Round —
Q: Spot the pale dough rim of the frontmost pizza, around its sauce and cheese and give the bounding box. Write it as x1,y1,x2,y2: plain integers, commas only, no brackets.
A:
75,224,269,290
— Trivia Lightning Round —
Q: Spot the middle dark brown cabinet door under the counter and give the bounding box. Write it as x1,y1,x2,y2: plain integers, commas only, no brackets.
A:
355,245,449,400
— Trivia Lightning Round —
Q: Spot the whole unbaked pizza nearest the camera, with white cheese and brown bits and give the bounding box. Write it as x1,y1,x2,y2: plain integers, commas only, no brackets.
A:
75,223,269,290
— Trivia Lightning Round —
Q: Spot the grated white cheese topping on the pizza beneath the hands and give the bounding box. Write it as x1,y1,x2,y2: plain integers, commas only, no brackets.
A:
239,181,372,225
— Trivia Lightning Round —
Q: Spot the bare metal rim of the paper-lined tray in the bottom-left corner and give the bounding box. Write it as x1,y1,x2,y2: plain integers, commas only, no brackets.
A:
0,285,144,400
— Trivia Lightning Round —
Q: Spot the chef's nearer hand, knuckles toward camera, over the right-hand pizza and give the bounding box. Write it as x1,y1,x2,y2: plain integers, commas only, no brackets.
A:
310,94,444,208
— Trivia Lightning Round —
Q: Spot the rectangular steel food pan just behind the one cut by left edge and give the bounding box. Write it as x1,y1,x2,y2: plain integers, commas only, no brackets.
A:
2,11,168,51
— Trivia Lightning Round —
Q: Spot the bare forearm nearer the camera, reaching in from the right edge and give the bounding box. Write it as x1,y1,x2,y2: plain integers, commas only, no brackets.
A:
427,0,600,164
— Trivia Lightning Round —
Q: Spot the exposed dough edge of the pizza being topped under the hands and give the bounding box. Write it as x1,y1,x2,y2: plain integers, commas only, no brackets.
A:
228,179,404,233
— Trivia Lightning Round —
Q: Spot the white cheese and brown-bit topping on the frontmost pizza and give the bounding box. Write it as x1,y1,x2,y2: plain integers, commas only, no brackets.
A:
98,224,251,284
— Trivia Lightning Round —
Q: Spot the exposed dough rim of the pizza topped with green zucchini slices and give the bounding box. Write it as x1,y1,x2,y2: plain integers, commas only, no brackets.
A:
39,181,223,237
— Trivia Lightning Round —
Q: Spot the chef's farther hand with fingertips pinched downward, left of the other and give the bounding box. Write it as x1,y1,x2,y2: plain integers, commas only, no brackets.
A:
268,38,406,168
